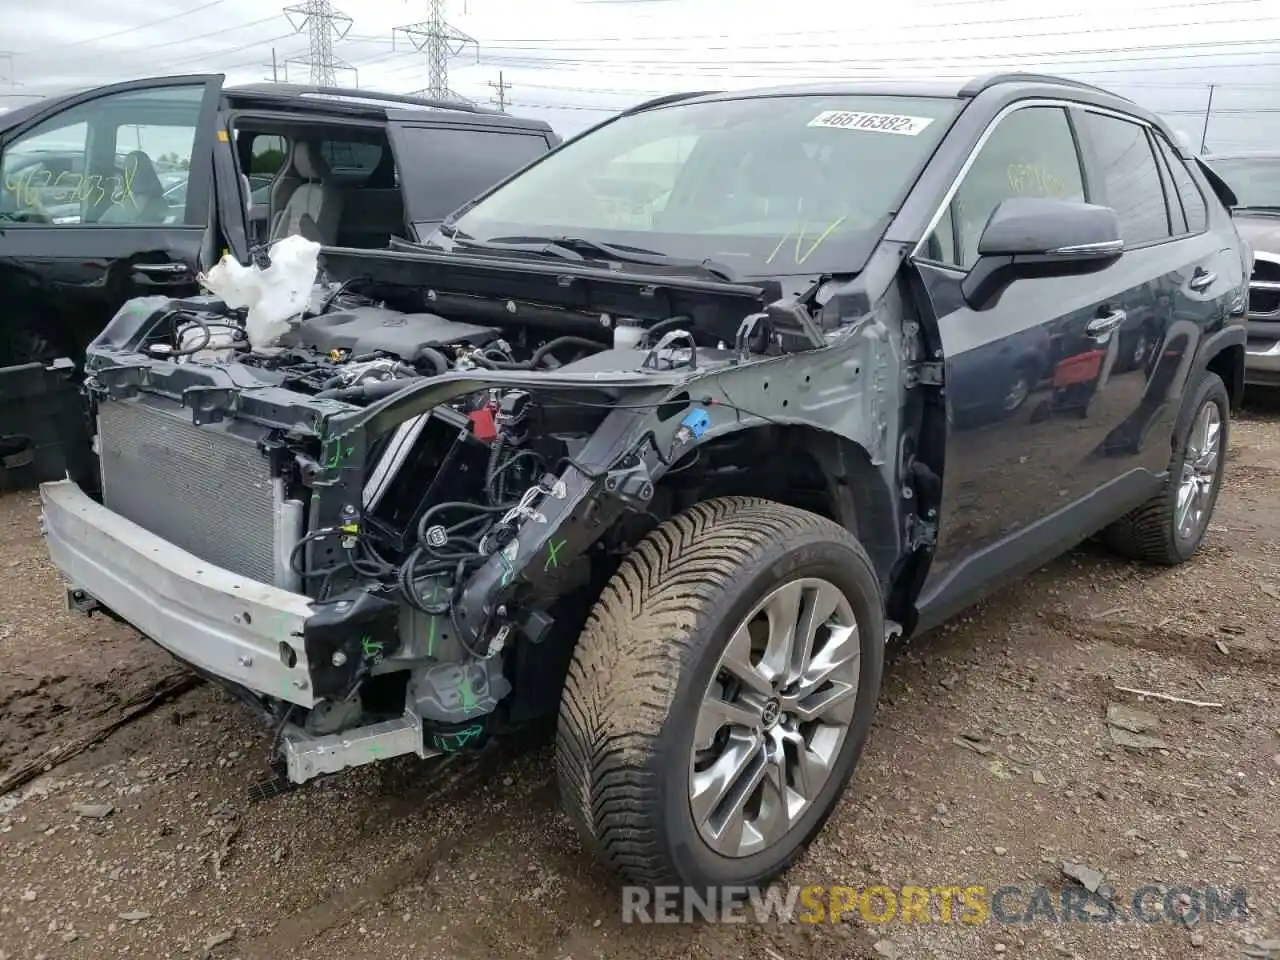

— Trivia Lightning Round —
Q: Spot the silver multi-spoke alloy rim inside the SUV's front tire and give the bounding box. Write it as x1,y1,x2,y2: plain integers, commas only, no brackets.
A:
689,577,861,858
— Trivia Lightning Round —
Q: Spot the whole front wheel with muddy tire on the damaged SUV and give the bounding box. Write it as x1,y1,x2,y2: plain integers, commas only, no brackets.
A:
556,497,884,890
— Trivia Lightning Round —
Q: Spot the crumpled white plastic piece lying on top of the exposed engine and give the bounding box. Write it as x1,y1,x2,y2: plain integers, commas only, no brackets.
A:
198,237,320,349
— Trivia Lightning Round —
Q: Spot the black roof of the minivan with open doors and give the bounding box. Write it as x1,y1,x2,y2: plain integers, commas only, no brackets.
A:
223,83,552,133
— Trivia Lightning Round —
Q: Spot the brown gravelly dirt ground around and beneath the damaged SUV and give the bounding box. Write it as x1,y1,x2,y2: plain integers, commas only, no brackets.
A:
0,391,1280,960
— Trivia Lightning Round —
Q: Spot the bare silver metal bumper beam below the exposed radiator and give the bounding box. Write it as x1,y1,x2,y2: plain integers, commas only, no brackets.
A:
40,480,315,708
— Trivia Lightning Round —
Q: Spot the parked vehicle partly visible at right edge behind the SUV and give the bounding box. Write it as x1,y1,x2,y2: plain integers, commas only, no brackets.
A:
1203,151,1280,387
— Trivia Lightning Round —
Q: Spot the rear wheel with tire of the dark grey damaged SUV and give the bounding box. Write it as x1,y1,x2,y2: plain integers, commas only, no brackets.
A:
1106,371,1230,566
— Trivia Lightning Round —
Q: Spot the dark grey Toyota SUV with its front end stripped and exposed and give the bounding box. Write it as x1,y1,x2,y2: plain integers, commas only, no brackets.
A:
41,74,1251,887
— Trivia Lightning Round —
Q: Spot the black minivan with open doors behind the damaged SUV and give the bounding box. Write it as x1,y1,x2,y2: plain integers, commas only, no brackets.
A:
0,76,559,485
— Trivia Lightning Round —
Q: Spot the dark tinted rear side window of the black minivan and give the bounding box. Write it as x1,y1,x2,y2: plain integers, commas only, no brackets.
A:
392,125,550,223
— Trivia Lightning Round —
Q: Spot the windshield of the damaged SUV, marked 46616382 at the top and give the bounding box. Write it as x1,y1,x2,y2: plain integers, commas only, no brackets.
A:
453,96,960,276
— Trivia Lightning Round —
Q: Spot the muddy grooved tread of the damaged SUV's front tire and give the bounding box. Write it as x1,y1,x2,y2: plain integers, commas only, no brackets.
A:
556,497,872,884
